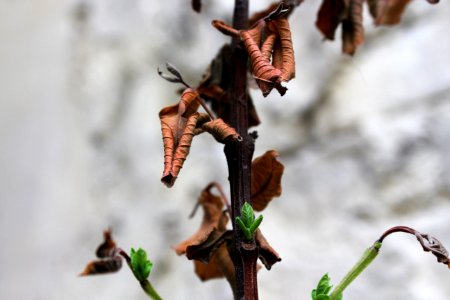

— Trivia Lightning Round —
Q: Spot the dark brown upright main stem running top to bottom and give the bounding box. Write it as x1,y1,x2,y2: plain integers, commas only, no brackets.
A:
225,0,258,300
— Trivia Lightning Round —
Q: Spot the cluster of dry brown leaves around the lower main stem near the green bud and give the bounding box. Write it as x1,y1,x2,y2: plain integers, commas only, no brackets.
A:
174,150,284,287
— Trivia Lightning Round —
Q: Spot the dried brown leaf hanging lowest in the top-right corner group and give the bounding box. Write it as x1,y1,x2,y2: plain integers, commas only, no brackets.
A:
342,0,364,55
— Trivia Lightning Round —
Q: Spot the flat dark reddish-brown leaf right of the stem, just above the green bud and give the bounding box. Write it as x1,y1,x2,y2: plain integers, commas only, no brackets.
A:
251,150,284,211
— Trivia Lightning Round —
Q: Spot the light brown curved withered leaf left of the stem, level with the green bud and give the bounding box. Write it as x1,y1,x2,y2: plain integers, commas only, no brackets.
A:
174,185,228,255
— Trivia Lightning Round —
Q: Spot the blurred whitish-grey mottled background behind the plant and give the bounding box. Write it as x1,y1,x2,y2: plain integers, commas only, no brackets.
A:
0,0,450,300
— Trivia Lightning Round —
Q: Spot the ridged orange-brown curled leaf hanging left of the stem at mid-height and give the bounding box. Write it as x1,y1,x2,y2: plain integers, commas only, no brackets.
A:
159,88,209,187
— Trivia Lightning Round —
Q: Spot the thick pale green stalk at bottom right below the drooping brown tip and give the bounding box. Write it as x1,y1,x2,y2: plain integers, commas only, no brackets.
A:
330,241,381,300
